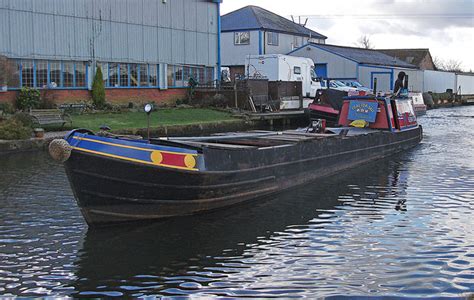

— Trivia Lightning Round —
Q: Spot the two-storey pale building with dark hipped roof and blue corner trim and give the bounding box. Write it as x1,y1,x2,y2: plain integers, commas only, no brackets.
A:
221,5,327,78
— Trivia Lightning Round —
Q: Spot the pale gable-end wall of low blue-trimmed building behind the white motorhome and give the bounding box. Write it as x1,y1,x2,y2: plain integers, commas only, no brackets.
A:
290,46,357,79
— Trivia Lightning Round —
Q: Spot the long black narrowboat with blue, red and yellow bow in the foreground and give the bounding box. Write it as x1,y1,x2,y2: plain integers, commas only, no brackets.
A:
50,96,422,226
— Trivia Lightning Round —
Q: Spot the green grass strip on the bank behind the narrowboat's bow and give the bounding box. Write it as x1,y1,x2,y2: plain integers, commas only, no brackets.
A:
66,108,235,131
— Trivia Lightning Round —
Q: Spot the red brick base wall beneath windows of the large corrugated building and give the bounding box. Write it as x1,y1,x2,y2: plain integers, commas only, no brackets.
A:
0,89,187,104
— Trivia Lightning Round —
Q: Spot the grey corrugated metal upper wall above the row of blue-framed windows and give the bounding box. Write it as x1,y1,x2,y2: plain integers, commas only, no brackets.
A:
0,0,217,66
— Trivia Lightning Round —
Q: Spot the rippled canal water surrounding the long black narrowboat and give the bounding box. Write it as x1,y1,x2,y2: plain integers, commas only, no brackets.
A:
0,106,474,297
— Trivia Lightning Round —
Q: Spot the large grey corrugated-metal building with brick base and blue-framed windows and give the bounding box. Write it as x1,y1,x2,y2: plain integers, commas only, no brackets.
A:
0,0,222,102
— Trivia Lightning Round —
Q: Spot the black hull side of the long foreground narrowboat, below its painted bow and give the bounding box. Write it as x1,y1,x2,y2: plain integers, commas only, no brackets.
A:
65,127,422,226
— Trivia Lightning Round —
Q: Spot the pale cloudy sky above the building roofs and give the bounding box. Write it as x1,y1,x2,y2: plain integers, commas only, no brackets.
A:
221,0,474,71
